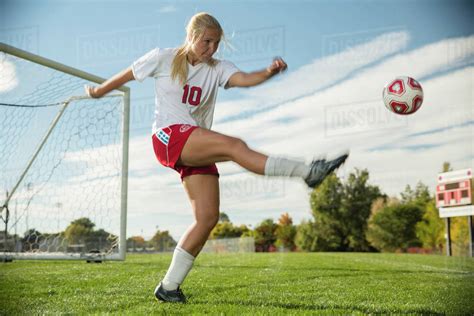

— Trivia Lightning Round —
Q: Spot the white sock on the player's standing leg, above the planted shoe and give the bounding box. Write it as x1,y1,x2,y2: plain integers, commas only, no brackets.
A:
161,246,195,291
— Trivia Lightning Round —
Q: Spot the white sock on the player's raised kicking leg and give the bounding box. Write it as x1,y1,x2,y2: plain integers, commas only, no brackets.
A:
265,157,311,179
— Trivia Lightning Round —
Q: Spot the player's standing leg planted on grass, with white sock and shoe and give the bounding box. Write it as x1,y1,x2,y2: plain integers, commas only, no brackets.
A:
155,174,219,302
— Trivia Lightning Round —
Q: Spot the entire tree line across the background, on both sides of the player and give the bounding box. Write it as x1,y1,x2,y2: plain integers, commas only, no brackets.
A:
3,163,469,255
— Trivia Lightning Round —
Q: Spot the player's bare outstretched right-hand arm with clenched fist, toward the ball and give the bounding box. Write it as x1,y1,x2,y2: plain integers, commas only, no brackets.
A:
227,57,288,88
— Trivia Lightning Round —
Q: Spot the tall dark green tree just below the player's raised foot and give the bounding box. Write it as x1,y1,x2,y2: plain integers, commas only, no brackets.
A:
311,169,382,251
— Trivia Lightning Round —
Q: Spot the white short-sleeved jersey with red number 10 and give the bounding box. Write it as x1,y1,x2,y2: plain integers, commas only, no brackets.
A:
132,48,239,133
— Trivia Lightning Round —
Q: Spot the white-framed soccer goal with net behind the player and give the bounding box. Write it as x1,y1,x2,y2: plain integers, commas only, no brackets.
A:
0,43,130,261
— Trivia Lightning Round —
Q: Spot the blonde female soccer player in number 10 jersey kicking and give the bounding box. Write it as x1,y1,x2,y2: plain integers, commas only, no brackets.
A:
85,13,348,302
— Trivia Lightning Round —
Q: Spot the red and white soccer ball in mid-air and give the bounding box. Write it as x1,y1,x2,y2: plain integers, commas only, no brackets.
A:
383,76,423,115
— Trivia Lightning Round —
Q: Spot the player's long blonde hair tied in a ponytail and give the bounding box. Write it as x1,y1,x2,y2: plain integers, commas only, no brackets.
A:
171,12,224,85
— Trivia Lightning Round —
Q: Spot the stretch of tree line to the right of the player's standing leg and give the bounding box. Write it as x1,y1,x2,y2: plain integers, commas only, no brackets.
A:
206,163,469,255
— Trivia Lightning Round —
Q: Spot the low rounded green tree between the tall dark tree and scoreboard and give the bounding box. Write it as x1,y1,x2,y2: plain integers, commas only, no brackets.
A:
367,203,423,251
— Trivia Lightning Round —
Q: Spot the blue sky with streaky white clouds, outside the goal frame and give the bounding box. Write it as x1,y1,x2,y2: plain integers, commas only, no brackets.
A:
0,0,474,237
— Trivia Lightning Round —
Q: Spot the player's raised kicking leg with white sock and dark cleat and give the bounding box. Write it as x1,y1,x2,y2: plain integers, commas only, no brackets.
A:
179,128,348,188
